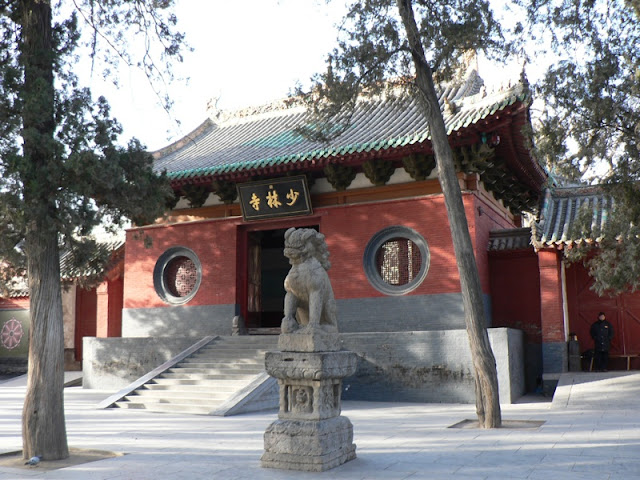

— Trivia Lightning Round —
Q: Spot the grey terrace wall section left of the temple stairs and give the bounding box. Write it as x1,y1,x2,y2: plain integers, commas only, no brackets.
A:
82,337,200,392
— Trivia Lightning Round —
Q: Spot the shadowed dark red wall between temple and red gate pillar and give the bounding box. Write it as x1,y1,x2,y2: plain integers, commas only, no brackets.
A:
489,249,542,344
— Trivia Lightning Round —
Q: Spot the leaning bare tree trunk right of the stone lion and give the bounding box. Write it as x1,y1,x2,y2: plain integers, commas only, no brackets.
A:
397,0,502,428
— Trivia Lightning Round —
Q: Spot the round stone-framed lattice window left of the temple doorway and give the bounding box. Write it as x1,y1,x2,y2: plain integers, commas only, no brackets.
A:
153,247,202,305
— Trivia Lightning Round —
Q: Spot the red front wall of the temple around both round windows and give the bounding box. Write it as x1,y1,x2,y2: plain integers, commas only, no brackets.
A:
124,193,509,308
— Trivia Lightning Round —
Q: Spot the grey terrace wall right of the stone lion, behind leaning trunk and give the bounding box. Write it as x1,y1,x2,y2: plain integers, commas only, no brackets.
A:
341,328,525,403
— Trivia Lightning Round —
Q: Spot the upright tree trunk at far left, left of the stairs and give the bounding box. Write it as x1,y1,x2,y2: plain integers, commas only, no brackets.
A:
20,0,69,460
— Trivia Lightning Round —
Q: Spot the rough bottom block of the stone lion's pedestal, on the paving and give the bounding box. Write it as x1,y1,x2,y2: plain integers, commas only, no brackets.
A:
261,416,356,472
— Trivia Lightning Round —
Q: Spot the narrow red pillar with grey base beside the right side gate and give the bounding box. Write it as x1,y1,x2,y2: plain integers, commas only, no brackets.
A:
538,249,568,379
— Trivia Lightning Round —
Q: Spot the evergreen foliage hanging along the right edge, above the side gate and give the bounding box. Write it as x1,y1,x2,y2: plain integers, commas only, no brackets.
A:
517,0,640,294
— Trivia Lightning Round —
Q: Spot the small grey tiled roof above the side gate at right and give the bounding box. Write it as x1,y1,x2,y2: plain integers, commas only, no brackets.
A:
533,186,613,248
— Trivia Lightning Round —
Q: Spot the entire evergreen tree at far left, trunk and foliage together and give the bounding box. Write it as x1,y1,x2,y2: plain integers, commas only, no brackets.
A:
0,0,183,460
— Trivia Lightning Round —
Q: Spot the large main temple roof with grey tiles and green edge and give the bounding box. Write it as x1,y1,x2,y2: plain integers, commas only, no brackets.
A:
154,72,528,181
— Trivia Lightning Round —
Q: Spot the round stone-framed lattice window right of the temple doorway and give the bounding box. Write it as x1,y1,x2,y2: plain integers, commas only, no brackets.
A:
363,225,430,295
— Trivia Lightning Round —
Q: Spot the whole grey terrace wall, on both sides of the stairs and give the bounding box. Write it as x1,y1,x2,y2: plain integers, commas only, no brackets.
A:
83,328,525,403
